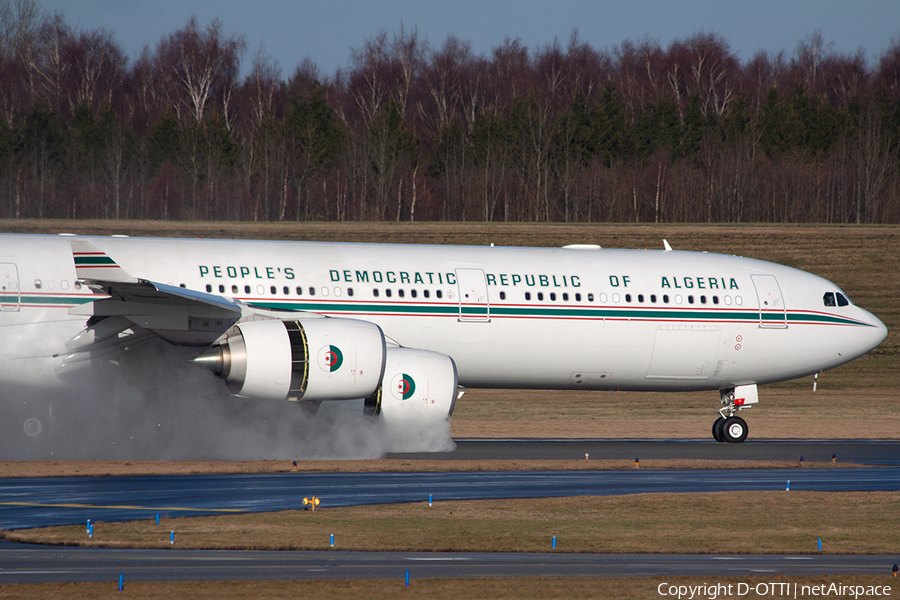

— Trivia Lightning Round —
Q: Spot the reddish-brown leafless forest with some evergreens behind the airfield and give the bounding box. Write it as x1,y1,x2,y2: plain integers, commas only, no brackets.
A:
0,0,900,223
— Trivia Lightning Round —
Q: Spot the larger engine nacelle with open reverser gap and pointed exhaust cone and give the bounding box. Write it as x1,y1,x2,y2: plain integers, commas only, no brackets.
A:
194,318,386,401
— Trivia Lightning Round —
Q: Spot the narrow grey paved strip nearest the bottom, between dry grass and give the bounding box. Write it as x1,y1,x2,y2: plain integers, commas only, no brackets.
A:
0,542,897,583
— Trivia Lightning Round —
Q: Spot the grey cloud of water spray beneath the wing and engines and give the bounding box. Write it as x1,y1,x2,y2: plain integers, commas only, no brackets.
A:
0,340,454,460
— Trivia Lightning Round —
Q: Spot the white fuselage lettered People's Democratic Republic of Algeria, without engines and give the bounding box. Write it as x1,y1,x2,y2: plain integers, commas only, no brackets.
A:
0,235,886,390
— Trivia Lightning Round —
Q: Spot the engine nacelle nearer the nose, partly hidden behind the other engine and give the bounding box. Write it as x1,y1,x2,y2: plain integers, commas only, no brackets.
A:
365,348,459,426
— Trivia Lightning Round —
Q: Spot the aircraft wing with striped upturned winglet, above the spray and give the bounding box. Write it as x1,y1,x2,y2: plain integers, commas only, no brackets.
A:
70,240,243,346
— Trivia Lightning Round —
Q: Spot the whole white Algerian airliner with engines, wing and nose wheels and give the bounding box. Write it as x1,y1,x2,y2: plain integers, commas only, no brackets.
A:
0,235,887,442
